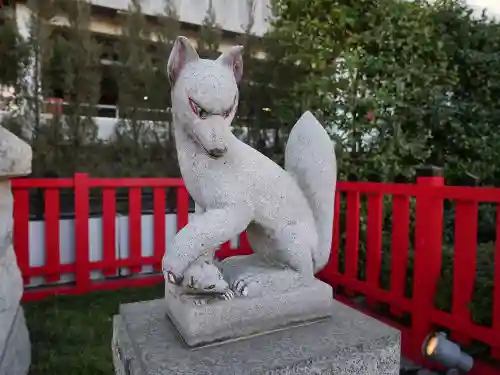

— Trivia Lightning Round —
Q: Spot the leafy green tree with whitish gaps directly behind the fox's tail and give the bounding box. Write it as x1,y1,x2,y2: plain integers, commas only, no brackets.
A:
268,0,466,181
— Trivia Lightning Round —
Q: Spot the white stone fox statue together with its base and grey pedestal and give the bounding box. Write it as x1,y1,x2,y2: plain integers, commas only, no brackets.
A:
113,37,400,375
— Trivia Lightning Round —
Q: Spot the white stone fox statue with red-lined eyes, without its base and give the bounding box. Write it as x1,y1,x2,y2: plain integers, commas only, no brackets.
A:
163,37,337,295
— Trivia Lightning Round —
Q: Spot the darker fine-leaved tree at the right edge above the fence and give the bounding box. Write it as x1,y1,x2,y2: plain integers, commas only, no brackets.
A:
426,0,500,185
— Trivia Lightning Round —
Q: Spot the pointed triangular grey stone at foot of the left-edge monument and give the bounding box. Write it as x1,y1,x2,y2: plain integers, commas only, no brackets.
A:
0,307,31,375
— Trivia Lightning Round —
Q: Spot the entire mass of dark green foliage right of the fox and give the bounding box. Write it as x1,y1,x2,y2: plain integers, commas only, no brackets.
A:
266,0,500,184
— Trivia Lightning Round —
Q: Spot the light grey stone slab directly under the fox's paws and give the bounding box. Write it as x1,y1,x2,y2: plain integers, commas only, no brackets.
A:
165,280,333,347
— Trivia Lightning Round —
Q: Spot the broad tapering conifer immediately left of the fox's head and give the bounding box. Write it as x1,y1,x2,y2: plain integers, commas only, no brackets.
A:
111,0,177,176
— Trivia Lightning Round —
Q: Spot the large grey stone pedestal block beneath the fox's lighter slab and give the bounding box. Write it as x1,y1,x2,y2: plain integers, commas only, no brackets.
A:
112,300,400,375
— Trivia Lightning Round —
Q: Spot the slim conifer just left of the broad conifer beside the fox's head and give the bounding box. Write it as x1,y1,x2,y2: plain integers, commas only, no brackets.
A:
42,0,102,175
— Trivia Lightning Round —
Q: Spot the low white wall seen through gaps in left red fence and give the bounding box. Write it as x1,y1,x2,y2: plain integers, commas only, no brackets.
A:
27,214,239,287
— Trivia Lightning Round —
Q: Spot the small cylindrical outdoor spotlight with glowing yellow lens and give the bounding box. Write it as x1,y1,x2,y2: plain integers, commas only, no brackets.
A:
422,332,474,372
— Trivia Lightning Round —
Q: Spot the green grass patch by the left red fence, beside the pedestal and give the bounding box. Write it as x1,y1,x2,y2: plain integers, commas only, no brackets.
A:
24,283,164,375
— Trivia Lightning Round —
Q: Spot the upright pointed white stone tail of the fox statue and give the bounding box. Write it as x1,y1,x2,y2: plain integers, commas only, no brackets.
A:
285,111,337,273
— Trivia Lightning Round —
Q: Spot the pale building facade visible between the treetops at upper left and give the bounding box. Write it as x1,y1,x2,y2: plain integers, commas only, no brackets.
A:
0,0,271,139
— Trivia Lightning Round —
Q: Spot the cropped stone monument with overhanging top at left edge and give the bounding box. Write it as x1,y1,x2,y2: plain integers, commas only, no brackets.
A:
0,126,31,375
